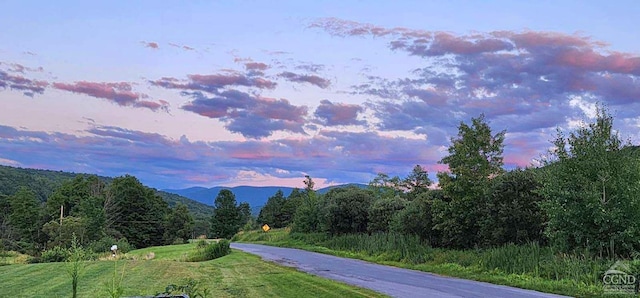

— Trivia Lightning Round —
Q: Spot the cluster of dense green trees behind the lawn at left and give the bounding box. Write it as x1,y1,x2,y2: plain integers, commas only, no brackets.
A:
0,175,194,255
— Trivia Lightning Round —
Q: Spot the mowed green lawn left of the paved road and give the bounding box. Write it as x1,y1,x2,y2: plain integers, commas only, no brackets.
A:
0,244,384,297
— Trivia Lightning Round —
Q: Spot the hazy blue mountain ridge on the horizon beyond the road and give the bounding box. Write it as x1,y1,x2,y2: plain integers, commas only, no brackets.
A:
163,183,367,213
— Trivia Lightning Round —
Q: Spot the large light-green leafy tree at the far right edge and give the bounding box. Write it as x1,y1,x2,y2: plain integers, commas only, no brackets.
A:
540,106,640,258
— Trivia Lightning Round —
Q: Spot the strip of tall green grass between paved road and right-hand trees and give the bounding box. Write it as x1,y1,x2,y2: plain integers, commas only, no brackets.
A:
233,229,614,297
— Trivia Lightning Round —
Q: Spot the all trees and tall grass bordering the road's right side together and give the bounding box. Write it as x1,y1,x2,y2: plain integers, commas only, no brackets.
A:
239,106,640,296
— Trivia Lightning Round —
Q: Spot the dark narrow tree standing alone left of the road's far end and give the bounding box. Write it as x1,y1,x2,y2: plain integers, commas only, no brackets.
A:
211,189,242,239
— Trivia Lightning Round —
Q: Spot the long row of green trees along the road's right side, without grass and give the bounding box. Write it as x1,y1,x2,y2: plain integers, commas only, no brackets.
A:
257,106,640,257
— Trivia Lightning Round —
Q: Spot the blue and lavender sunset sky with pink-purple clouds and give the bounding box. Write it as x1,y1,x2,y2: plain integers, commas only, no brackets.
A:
0,0,640,188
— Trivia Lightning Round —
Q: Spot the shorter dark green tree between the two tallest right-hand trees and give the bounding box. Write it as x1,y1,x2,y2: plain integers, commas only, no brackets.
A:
480,169,546,246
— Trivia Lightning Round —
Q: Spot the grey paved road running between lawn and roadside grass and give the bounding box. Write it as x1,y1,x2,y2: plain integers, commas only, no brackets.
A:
231,243,562,298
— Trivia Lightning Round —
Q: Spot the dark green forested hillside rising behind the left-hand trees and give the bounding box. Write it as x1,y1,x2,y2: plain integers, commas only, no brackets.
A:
0,165,213,219
